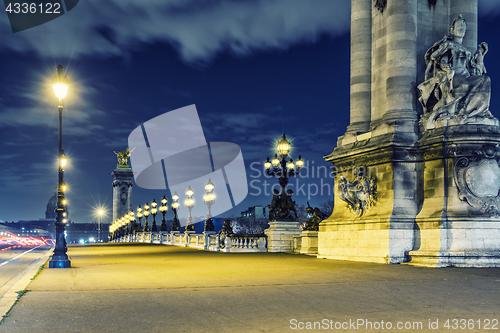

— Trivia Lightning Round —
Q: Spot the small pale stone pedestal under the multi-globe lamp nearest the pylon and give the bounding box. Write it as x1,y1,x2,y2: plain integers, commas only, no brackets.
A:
264,221,302,253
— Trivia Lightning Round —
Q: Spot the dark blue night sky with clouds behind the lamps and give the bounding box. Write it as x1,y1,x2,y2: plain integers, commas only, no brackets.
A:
0,0,500,222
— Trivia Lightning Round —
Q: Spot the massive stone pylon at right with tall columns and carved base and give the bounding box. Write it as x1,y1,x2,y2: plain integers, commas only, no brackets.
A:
318,0,500,266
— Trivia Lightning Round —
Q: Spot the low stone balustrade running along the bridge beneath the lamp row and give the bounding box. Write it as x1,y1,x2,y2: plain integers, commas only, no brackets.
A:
112,231,267,252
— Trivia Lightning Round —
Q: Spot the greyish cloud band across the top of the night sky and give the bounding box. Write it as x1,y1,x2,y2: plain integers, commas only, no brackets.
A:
0,0,350,62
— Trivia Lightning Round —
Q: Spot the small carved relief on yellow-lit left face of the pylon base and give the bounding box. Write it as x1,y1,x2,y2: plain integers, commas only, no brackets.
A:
339,167,377,217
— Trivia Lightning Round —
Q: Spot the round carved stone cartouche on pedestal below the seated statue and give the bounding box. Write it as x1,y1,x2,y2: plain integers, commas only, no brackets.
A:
454,145,500,215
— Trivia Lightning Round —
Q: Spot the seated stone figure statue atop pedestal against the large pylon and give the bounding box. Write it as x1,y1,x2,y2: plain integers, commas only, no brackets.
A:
418,15,498,130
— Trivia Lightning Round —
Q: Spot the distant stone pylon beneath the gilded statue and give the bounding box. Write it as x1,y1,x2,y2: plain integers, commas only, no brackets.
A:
110,167,134,221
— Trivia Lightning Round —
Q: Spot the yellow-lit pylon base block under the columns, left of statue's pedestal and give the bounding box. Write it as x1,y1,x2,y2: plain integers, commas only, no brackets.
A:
318,139,418,263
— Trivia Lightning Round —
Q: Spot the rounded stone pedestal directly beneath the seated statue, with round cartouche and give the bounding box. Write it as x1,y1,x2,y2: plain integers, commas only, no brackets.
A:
409,125,500,267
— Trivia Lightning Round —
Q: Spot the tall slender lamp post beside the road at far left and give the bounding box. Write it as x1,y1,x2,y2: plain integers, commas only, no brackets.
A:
49,65,71,268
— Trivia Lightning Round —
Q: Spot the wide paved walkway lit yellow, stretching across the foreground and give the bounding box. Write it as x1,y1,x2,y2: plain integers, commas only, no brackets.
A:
0,244,500,333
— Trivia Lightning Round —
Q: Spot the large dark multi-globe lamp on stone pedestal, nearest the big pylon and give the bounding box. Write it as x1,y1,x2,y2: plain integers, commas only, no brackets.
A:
264,133,304,221
